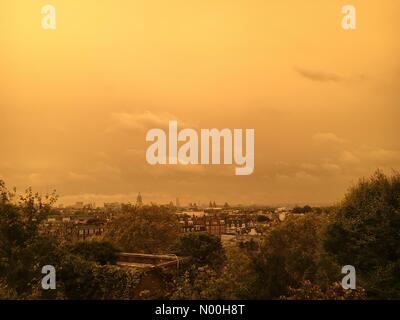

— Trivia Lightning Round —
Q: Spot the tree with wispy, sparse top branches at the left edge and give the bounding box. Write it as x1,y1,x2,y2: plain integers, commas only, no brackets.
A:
0,181,60,297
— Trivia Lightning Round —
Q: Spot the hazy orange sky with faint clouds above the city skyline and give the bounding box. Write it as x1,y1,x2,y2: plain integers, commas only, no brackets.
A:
0,0,400,205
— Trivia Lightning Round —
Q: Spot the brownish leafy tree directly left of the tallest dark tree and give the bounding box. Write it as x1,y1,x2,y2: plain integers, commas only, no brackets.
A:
248,215,335,299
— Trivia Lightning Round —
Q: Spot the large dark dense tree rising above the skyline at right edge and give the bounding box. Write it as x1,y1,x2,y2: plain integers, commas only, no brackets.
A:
324,171,400,299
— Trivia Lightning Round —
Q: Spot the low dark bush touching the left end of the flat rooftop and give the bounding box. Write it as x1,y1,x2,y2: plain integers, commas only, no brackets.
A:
66,241,118,265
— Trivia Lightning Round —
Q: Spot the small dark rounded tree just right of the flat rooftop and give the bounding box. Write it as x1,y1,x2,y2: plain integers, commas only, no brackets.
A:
176,232,225,268
